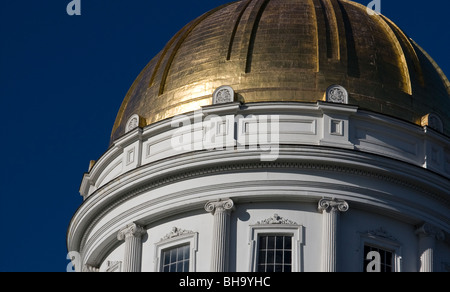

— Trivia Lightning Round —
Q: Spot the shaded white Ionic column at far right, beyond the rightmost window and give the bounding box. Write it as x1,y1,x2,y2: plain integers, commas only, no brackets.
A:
416,223,444,273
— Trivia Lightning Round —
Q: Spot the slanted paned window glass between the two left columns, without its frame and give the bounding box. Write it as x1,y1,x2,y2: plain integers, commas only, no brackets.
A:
161,244,190,272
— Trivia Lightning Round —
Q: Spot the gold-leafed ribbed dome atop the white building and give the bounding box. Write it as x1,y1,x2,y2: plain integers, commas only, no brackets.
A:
111,0,450,142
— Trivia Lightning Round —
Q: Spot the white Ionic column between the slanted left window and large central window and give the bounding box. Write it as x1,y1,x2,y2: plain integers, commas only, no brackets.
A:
205,199,234,272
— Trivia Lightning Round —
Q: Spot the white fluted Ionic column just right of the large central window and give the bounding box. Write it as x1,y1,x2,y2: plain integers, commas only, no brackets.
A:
318,198,348,272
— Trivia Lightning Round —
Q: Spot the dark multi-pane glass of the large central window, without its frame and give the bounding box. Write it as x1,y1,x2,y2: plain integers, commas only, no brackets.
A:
257,235,292,272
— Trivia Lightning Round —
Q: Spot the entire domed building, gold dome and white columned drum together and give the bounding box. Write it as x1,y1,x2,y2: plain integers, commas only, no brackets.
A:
67,0,450,272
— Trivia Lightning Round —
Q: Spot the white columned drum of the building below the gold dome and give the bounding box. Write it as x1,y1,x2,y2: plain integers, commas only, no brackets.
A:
67,1,450,272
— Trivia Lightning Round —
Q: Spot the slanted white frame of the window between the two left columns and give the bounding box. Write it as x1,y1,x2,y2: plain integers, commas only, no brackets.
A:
154,232,198,272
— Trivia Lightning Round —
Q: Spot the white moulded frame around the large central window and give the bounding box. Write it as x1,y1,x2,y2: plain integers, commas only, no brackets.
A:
249,224,305,272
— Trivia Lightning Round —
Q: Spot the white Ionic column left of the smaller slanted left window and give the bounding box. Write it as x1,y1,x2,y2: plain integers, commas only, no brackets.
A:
117,223,146,272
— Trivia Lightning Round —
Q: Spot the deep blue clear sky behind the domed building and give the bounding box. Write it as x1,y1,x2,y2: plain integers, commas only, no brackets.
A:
0,0,450,272
